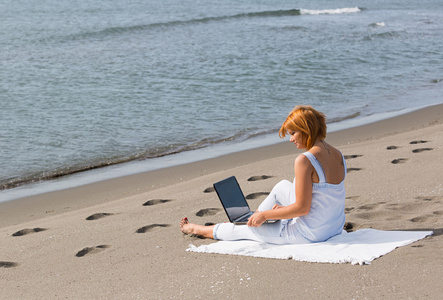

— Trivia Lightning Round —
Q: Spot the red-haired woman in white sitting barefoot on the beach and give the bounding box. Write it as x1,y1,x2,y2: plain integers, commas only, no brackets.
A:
180,106,346,244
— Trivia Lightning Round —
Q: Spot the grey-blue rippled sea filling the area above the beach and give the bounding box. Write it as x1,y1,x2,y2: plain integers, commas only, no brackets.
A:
0,0,443,201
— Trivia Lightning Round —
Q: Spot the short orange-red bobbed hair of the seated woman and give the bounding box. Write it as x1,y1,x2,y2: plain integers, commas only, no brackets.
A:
278,105,326,150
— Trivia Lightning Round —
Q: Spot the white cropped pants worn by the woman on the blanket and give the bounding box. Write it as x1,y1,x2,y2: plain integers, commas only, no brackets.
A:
213,180,308,244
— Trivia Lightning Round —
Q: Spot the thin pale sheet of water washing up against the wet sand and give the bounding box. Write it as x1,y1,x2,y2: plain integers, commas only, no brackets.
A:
0,104,436,203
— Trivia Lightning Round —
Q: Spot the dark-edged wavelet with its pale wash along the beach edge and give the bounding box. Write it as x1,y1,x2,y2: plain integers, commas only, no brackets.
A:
0,104,424,192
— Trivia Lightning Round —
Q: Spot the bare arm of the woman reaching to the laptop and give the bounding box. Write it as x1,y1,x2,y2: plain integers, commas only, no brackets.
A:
248,155,315,227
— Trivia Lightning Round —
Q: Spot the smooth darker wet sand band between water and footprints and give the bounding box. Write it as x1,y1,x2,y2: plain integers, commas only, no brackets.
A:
0,104,443,227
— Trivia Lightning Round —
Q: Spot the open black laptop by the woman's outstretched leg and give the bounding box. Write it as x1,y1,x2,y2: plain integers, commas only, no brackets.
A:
214,176,277,224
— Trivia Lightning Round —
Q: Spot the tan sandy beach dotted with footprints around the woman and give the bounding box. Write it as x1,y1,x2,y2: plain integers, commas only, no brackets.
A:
0,105,443,299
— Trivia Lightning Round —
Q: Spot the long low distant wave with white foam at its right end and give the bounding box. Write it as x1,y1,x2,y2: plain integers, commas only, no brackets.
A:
57,7,361,41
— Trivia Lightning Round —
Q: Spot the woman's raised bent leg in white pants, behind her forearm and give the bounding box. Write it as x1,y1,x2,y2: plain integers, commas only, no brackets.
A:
258,180,295,211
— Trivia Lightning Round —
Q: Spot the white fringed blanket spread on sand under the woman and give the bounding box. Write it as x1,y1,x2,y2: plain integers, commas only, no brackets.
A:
186,229,433,265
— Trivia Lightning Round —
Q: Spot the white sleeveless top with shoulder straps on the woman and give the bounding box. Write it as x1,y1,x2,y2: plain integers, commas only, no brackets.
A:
291,152,346,242
